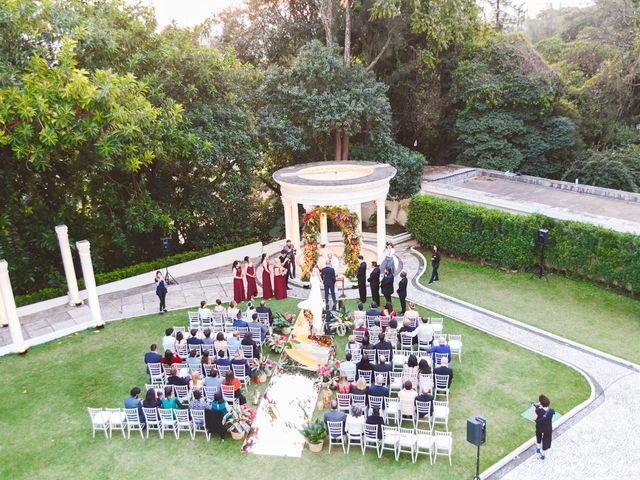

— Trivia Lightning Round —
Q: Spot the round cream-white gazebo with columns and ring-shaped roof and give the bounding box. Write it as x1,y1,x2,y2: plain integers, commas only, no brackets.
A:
273,160,396,260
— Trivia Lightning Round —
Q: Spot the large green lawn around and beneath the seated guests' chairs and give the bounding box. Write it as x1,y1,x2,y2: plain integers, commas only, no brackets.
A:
0,298,589,480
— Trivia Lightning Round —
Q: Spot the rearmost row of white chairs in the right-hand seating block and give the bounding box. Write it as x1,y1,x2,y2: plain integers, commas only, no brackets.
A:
327,422,453,465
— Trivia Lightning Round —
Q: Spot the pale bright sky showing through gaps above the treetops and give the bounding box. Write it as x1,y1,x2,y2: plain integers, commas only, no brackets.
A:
135,0,593,27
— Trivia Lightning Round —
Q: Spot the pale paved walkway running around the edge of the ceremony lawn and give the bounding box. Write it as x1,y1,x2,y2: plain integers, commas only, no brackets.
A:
0,243,640,480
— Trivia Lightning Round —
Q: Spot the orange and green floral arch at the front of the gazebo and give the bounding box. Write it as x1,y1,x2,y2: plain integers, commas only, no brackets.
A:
302,206,360,281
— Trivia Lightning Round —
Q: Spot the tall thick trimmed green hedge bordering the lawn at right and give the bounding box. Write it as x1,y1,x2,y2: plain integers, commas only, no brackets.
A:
407,195,640,293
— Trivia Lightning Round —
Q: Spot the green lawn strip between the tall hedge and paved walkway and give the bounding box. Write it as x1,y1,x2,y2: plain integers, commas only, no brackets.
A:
420,252,640,363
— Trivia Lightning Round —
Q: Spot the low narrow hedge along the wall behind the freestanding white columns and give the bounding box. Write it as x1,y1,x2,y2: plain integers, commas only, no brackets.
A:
16,238,257,307
